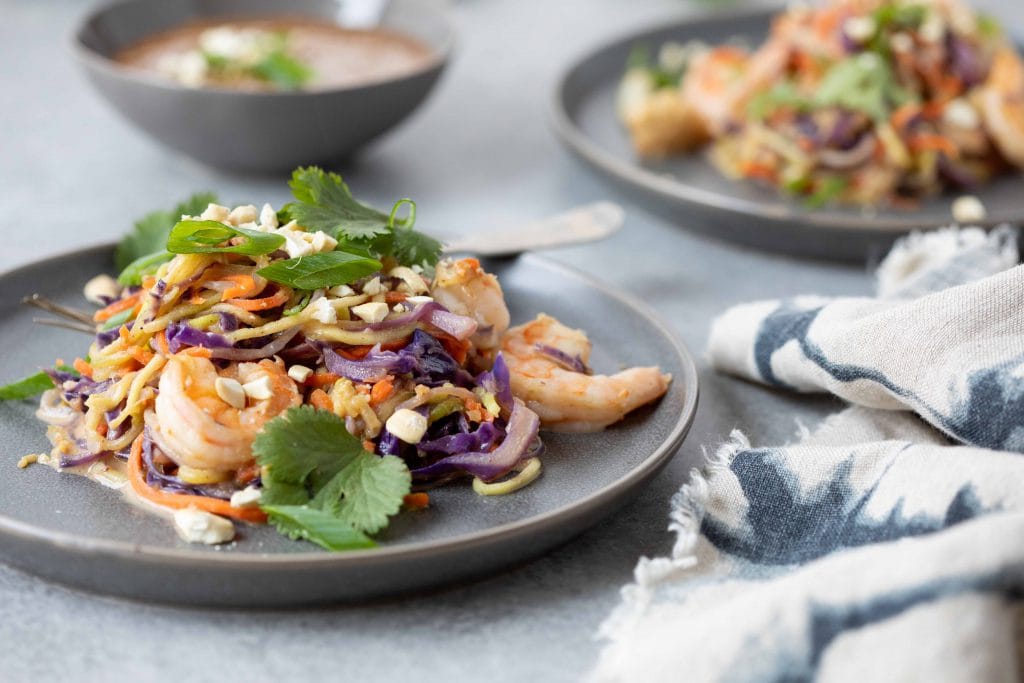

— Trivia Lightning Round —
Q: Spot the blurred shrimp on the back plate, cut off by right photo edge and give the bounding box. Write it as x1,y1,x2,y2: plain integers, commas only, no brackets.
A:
978,46,1024,168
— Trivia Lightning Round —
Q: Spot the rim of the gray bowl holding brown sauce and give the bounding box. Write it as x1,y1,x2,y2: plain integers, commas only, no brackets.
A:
67,0,457,98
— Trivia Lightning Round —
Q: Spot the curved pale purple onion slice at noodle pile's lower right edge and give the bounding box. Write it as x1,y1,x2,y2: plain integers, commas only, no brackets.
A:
413,398,541,481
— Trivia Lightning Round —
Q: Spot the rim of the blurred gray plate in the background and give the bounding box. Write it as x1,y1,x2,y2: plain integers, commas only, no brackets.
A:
548,4,1024,238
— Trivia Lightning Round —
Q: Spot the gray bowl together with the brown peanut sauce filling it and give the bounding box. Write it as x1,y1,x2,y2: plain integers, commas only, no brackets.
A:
72,0,455,172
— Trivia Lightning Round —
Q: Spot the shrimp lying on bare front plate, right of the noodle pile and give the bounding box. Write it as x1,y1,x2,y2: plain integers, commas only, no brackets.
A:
502,313,672,432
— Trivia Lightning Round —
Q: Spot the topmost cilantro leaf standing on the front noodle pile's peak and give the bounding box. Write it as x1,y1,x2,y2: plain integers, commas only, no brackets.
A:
285,166,388,242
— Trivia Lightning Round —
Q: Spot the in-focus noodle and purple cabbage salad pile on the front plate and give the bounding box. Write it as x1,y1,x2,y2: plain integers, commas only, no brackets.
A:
0,168,548,550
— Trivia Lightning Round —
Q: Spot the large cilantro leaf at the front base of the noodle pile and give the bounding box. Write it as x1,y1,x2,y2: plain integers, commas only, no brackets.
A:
253,405,412,547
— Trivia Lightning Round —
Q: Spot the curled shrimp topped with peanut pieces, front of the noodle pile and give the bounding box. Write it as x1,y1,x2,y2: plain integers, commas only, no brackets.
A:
146,354,302,471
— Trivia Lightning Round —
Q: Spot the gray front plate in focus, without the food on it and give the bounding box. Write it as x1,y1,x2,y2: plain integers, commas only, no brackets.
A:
0,247,697,606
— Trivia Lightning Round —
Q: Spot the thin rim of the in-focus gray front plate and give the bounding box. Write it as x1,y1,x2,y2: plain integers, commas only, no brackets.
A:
0,242,699,570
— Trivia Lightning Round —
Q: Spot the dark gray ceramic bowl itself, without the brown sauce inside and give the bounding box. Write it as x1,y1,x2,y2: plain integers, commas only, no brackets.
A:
73,0,454,171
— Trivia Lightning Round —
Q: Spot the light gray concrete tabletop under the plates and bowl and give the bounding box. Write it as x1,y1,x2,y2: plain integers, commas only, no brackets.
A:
0,0,1024,683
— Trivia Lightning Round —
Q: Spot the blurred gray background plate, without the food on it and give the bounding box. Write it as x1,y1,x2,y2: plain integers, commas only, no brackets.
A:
553,9,1024,261
